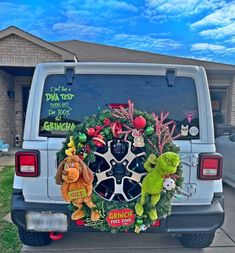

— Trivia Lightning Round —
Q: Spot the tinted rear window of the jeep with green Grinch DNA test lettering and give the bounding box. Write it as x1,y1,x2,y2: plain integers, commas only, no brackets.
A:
39,74,200,139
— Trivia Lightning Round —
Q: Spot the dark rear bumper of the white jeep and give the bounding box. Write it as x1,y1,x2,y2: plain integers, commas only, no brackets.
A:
11,190,224,234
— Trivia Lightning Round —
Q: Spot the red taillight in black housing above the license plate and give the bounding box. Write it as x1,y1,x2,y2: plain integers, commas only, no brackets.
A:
15,150,40,177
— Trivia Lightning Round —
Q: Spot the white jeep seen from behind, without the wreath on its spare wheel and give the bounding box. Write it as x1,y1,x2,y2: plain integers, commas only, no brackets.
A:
11,63,224,248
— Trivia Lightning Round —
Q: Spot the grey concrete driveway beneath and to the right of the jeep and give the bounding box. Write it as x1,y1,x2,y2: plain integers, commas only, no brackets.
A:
21,185,235,253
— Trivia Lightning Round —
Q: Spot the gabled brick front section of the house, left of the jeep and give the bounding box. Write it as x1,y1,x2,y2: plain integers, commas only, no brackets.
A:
0,27,75,146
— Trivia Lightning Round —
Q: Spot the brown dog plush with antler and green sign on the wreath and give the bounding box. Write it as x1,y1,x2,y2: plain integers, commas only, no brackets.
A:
55,155,100,221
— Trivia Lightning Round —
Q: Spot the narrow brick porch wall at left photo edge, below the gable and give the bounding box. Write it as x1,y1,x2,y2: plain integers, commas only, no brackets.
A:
0,70,15,145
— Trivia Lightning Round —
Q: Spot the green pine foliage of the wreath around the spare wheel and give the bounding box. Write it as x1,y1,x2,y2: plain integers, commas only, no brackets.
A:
57,106,183,233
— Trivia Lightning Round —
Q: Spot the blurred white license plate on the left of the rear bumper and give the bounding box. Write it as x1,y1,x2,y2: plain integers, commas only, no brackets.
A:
26,212,68,231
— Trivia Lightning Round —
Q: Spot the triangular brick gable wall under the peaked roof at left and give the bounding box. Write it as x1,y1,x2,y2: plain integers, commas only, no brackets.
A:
0,34,62,67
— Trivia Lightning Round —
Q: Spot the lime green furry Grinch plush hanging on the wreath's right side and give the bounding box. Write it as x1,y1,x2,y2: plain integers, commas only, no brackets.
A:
135,152,180,220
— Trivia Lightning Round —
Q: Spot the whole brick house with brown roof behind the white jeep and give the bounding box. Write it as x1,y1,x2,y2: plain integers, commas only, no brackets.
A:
0,27,235,146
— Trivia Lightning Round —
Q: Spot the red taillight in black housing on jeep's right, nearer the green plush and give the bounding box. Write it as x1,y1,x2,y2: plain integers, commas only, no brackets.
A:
198,153,223,180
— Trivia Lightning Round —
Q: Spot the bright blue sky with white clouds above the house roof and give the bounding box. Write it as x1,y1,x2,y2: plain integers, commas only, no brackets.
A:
0,0,235,64
